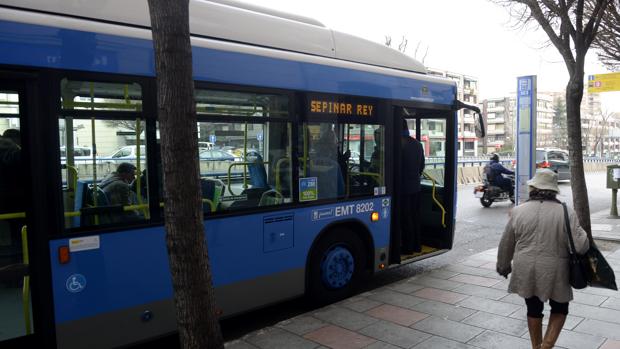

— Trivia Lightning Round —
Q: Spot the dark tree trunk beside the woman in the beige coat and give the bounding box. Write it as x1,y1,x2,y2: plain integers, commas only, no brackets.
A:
566,60,592,241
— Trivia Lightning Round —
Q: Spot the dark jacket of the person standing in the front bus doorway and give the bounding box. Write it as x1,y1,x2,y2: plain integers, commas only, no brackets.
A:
401,136,424,194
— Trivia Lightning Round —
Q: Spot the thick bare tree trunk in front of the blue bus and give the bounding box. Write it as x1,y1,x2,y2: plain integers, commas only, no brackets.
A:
148,0,224,349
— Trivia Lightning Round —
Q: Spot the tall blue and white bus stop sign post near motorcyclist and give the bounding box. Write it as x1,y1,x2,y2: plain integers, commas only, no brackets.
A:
515,75,537,205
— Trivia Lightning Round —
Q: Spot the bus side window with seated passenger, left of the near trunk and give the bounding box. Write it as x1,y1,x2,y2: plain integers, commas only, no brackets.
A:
58,79,150,228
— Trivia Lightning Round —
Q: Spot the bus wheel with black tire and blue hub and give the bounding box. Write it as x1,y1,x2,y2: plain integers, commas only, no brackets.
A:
307,228,366,305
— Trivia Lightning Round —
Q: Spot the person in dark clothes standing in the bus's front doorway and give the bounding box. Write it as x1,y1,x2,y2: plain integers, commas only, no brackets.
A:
400,119,424,254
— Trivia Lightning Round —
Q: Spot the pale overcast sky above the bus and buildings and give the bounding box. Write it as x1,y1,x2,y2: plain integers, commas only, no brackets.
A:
251,0,620,112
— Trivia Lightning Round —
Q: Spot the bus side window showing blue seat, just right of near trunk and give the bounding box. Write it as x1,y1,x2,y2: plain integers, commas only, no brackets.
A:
196,89,292,214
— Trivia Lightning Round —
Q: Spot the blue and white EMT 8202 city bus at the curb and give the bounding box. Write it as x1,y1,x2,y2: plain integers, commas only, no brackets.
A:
0,0,483,349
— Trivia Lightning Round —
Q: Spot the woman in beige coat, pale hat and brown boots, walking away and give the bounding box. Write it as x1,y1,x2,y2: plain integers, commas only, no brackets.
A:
497,169,589,348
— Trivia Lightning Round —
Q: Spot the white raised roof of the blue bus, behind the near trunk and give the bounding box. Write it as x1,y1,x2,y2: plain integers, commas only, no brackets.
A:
3,0,426,74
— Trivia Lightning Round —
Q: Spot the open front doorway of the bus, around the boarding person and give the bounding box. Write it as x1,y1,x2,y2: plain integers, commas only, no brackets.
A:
390,108,456,263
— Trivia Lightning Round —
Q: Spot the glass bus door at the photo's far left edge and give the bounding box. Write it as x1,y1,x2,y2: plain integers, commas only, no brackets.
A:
0,82,33,345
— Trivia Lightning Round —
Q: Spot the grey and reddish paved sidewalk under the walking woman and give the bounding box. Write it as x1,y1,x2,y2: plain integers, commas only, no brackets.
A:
226,222,620,349
